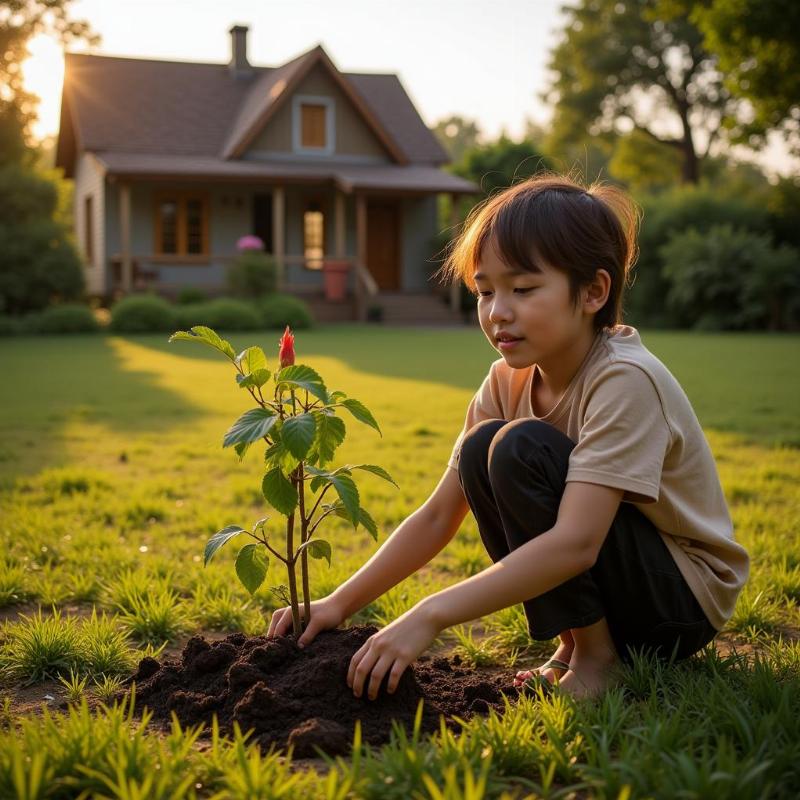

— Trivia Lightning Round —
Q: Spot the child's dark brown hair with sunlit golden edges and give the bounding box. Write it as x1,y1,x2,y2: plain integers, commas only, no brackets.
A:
440,173,641,330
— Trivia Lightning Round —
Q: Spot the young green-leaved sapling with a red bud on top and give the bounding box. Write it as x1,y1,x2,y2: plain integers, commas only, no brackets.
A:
169,325,397,636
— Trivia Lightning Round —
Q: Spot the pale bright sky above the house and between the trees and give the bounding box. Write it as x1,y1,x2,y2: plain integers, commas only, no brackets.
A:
23,0,796,174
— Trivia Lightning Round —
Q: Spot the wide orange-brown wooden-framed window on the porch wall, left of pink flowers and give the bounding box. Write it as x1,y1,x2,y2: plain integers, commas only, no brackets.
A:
155,192,208,256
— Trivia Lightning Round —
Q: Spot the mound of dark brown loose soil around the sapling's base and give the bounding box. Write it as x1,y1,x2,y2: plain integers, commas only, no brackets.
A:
122,625,517,758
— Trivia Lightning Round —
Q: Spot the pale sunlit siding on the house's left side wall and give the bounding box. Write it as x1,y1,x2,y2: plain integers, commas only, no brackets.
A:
73,153,106,295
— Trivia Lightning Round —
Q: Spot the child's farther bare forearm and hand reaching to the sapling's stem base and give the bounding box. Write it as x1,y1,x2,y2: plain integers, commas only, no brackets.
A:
268,467,469,645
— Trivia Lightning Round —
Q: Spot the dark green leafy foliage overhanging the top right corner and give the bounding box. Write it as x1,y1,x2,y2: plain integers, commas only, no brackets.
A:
684,0,800,152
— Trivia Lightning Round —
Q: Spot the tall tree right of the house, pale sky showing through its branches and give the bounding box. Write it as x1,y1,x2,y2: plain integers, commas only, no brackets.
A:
544,0,738,183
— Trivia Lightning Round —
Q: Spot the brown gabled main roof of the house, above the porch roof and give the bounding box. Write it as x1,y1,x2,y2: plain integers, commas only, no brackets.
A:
56,45,456,176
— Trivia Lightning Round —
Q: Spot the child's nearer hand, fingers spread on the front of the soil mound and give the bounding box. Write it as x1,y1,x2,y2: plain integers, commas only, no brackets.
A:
347,603,441,700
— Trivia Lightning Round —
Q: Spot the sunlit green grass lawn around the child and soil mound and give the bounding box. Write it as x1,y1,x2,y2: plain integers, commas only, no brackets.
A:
0,324,800,800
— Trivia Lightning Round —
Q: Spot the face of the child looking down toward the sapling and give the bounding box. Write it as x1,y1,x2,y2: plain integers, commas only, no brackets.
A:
475,233,591,369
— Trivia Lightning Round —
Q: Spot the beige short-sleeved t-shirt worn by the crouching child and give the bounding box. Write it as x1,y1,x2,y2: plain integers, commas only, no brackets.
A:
448,325,750,630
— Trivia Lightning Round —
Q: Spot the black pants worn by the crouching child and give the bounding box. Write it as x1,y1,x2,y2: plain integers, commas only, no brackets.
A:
458,419,717,664
